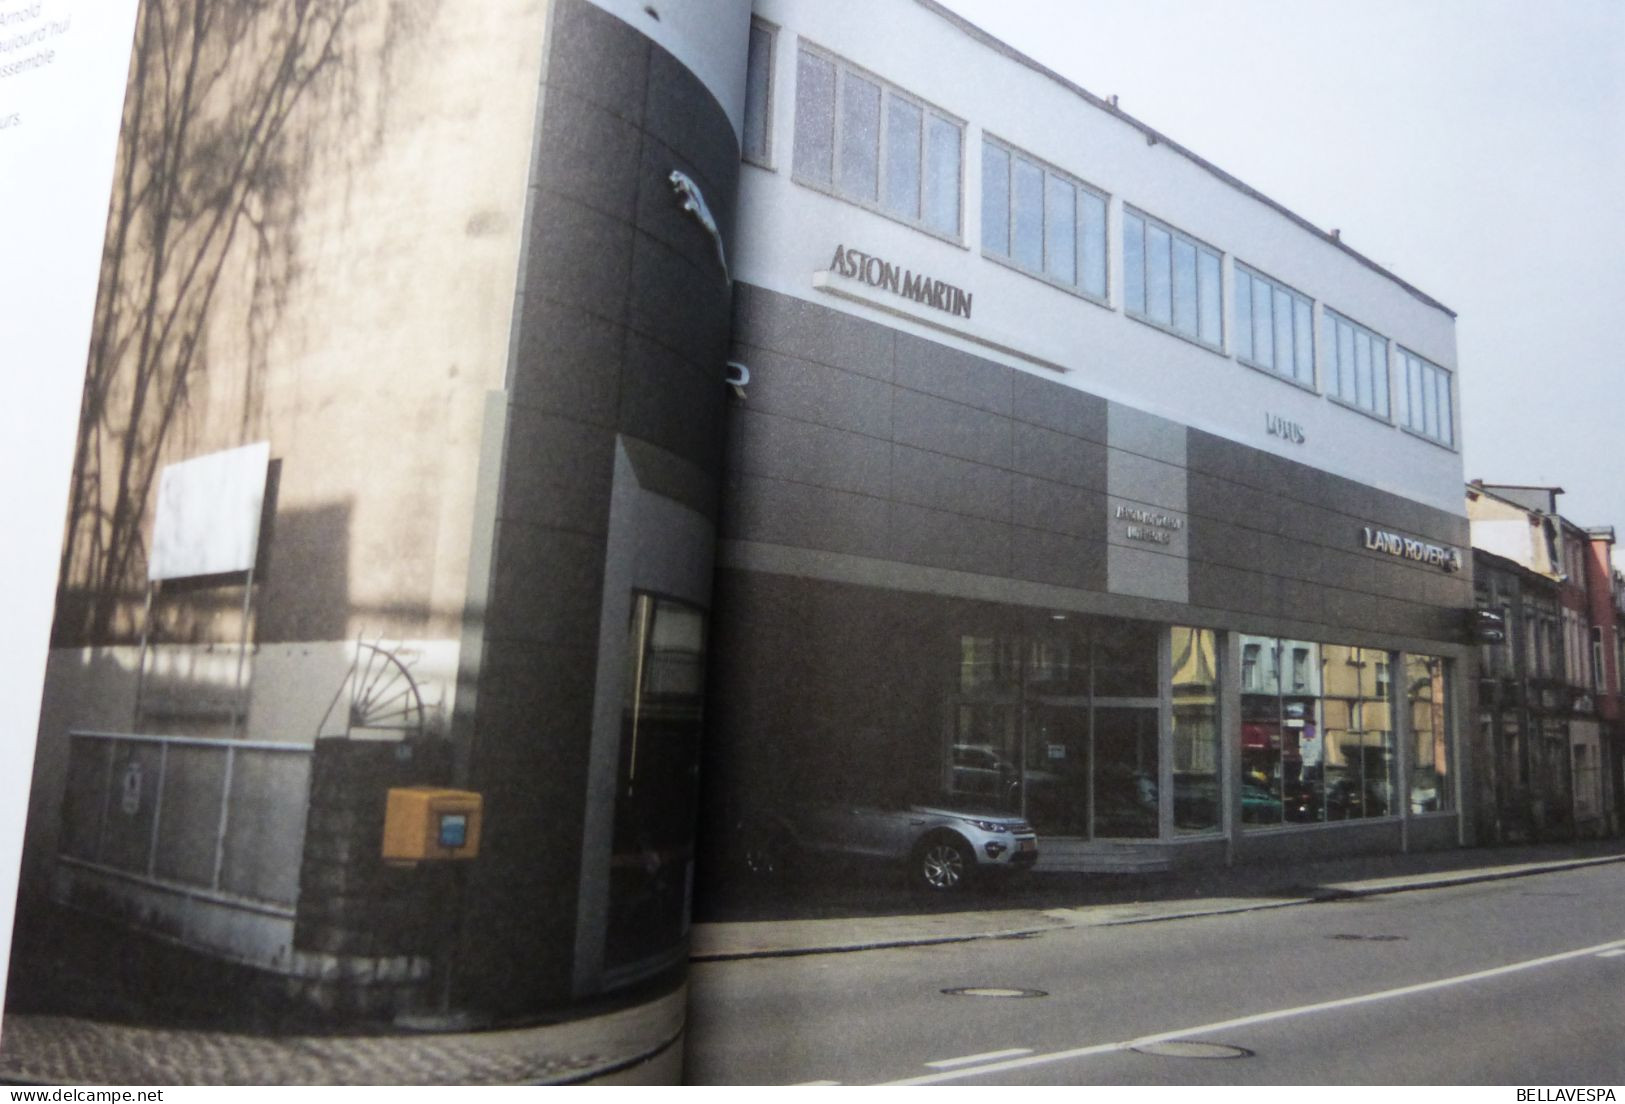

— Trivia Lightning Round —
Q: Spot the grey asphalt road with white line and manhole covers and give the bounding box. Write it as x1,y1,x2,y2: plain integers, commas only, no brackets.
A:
686,863,1625,1086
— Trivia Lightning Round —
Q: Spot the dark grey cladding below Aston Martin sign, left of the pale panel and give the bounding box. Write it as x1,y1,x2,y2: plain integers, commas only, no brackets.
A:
722,286,1107,590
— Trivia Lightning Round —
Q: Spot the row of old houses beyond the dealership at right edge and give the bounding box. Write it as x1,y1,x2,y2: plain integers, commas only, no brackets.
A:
1467,481,1625,842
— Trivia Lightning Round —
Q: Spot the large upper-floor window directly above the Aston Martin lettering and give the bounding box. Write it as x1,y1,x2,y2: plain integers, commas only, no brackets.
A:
793,46,965,241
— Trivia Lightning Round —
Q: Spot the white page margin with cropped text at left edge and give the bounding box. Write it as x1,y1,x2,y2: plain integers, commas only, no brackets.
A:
0,0,137,1021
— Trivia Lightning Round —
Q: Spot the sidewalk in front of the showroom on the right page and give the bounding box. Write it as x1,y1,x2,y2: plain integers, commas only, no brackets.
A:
691,841,1625,963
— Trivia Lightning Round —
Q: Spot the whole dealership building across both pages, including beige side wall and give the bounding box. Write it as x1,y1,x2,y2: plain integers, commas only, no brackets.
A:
20,0,1472,1019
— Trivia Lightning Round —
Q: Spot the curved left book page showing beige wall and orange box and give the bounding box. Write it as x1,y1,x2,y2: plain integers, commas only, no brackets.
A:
0,0,749,1084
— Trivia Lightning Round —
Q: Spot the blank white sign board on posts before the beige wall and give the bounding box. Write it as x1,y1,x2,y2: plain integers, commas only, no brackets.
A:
146,441,271,580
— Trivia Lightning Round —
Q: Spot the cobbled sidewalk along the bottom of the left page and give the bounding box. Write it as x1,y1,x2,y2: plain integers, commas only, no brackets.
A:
0,987,687,1084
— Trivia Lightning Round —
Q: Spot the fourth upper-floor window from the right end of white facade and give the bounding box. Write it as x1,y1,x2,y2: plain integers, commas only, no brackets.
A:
1123,208,1224,350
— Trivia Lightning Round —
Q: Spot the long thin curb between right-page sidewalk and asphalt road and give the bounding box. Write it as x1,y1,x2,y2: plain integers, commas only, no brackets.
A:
689,854,1625,963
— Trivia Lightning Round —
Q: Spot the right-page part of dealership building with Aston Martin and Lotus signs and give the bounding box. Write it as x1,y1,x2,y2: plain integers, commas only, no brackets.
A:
705,0,1472,870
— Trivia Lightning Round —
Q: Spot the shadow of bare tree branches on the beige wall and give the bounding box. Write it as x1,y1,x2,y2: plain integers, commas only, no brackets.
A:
52,0,439,647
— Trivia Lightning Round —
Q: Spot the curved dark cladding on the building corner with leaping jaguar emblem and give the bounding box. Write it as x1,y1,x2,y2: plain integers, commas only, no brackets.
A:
453,0,739,1016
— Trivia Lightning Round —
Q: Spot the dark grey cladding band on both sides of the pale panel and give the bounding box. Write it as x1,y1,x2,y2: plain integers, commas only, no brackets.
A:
723,286,1471,641
